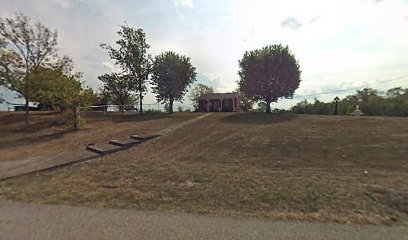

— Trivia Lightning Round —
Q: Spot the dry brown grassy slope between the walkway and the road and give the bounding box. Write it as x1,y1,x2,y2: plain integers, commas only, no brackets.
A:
0,113,408,224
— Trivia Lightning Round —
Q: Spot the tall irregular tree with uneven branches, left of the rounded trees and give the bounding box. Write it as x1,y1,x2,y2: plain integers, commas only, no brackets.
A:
101,25,151,114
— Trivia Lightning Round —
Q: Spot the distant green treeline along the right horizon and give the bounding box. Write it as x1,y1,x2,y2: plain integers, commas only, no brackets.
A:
291,87,408,116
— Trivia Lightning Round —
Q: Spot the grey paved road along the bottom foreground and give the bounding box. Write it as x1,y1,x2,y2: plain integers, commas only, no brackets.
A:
0,199,408,240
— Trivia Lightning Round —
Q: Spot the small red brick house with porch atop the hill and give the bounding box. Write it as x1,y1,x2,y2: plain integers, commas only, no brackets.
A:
198,93,240,112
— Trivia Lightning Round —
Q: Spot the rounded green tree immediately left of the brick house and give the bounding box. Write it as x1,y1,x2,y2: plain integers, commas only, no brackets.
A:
152,51,197,113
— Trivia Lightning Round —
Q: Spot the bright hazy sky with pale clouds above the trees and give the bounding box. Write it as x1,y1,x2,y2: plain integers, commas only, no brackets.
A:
0,0,408,108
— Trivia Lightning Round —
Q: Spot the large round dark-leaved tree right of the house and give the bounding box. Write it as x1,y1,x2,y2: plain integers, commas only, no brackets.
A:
238,44,301,113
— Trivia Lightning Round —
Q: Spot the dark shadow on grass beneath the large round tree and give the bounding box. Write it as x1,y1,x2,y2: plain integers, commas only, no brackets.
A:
220,113,297,124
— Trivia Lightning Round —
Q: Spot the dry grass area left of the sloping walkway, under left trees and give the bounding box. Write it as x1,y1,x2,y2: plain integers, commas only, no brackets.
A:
0,112,197,161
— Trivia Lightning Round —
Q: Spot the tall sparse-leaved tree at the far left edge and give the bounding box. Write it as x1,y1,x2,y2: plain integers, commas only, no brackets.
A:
0,13,57,124
